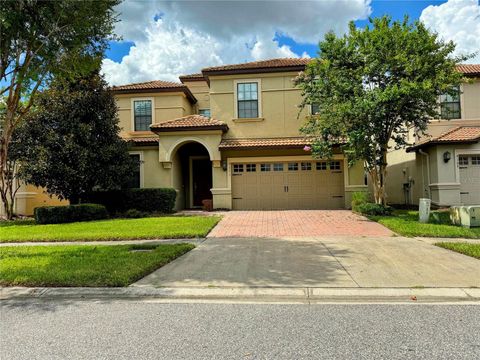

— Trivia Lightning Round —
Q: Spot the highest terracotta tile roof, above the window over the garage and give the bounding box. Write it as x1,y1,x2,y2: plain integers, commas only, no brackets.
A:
202,58,311,75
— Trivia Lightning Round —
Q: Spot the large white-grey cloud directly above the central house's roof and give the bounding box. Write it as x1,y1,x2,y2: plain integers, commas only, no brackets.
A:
103,0,371,84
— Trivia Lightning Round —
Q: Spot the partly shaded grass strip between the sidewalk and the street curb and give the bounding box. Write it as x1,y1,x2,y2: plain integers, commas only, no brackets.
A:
0,244,194,287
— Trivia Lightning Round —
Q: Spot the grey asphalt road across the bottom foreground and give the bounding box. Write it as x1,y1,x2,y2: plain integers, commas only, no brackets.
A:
0,300,480,360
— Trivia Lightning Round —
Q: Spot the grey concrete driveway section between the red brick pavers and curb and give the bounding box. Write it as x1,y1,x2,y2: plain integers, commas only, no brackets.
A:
134,236,480,287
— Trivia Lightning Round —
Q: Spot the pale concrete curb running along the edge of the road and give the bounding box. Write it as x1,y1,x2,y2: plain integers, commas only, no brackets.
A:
0,286,480,304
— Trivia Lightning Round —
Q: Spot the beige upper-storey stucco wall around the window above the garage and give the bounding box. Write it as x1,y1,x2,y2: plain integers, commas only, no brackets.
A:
210,72,307,138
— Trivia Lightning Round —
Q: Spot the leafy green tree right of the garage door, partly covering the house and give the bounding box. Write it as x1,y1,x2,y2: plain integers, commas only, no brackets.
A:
297,16,466,204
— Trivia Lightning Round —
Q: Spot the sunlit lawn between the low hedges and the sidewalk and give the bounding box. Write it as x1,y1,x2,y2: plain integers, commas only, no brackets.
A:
0,216,220,242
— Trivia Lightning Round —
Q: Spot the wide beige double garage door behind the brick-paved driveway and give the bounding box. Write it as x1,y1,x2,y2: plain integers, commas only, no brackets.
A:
231,160,345,210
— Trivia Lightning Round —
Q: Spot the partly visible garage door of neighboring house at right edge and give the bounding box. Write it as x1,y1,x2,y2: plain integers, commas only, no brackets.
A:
458,155,480,205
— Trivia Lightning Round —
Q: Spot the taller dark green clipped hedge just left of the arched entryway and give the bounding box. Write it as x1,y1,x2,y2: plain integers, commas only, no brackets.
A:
82,188,177,214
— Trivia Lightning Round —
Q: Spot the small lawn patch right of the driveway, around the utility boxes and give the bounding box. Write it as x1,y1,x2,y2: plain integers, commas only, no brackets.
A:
370,210,480,239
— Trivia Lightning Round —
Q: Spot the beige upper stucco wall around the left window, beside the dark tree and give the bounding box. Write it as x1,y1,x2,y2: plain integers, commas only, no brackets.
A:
115,92,193,135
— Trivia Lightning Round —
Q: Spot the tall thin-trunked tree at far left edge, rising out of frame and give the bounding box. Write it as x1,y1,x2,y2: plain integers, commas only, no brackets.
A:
0,0,120,215
